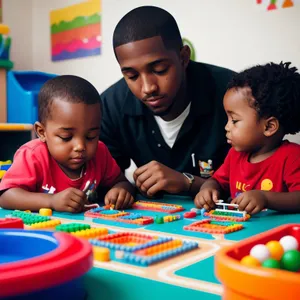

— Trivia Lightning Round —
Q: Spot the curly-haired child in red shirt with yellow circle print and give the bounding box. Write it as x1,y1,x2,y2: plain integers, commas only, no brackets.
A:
195,63,300,214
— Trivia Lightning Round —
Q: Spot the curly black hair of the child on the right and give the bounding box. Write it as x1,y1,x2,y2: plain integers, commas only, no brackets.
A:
228,62,300,134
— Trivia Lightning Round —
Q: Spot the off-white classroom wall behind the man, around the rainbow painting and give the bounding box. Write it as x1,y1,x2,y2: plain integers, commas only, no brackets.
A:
3,0,300,142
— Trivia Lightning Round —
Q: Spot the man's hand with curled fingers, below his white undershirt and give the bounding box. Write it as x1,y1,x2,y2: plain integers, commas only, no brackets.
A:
133,161,189,197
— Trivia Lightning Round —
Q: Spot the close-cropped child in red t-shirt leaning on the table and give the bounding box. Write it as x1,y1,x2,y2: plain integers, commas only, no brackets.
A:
0,75,134,213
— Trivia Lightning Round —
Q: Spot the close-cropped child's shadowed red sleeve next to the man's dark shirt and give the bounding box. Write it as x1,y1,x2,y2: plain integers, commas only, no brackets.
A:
98,143,121,187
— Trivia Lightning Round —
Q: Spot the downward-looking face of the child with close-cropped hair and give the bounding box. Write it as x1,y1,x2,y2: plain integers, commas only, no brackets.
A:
44,99,101,178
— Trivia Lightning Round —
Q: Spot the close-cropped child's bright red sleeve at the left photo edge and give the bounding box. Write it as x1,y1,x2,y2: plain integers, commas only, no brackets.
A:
0,147,42,192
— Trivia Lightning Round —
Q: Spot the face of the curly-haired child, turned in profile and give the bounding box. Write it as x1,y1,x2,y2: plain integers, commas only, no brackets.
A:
223,87,265,152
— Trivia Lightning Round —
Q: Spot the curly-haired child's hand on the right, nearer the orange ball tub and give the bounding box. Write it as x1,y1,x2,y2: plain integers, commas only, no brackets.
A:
231,190,268,215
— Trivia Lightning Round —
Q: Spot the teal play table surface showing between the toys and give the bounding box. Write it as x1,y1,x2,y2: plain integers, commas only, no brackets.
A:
0,195,300,300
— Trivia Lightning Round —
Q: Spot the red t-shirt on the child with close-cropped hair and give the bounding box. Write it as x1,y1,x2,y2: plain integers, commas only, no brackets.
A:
0,139,120,194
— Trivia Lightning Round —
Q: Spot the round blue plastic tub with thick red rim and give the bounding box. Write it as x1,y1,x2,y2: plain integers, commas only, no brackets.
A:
0,229,93,300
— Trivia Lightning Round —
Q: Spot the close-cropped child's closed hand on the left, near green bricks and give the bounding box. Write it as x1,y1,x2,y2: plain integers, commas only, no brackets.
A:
51,188,87,213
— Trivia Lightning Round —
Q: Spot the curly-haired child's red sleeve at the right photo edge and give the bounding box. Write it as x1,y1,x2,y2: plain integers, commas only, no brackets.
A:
283,153,300,192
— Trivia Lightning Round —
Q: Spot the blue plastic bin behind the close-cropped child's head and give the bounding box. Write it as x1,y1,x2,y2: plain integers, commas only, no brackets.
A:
7,71,56,124
